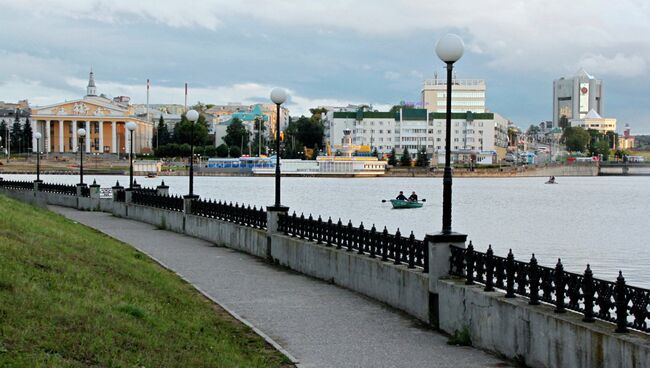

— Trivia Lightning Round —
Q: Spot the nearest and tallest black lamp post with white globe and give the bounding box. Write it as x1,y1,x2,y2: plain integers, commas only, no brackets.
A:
436,34,464,234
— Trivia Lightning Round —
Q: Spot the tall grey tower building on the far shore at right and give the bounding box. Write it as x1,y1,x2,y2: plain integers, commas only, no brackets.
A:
553,69,604,127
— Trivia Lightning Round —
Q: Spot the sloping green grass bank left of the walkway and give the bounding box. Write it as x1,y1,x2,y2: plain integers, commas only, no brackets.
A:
0,196,290,367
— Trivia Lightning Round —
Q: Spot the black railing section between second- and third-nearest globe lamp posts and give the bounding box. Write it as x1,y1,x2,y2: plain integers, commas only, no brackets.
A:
192,199,266,229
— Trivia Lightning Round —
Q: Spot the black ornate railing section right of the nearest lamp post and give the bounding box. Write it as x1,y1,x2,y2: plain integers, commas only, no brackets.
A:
450,242,650,332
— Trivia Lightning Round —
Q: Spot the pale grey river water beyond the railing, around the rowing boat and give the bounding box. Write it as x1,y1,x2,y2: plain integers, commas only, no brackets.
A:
2,175,650,288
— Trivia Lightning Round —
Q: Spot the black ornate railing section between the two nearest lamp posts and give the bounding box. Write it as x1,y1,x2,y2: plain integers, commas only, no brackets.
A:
278,212,429,272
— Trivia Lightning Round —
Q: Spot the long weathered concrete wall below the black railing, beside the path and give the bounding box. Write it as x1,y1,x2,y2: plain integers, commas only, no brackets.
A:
0,188,650,368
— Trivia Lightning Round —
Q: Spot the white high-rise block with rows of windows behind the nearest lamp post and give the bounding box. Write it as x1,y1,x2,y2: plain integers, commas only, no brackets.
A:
422,75,487,113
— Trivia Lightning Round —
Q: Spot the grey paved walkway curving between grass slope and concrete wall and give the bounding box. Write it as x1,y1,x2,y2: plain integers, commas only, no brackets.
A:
49,206,511,368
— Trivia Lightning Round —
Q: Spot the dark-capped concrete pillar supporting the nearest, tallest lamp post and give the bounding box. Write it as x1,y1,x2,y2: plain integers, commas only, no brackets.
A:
424,233,467,327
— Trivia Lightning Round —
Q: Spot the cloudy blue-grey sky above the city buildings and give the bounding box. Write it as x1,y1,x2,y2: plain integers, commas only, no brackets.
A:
0,0,650,134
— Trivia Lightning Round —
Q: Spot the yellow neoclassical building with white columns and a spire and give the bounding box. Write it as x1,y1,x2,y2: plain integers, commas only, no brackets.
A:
31,71,154,154
